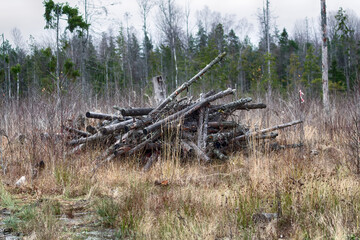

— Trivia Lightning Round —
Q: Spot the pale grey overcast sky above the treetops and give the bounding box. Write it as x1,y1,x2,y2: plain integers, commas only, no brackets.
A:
0,0,360,46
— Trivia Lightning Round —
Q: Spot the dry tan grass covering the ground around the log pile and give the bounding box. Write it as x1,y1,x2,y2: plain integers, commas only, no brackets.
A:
0,93,360,239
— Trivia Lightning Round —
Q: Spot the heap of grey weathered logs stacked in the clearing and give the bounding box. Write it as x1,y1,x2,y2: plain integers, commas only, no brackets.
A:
64,53,302,169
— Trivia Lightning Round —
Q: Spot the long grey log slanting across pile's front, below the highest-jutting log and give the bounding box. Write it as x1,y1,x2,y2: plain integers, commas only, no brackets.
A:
143,88,235,134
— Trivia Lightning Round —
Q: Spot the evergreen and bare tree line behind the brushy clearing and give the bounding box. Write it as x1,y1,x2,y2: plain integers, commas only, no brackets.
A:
0,0,360,102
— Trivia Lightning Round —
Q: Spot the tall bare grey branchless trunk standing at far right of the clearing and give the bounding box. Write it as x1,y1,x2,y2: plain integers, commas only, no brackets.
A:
321,0,330,115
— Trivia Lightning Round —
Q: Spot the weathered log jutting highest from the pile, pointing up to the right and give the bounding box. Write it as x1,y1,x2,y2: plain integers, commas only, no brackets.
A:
149,52,226,115
